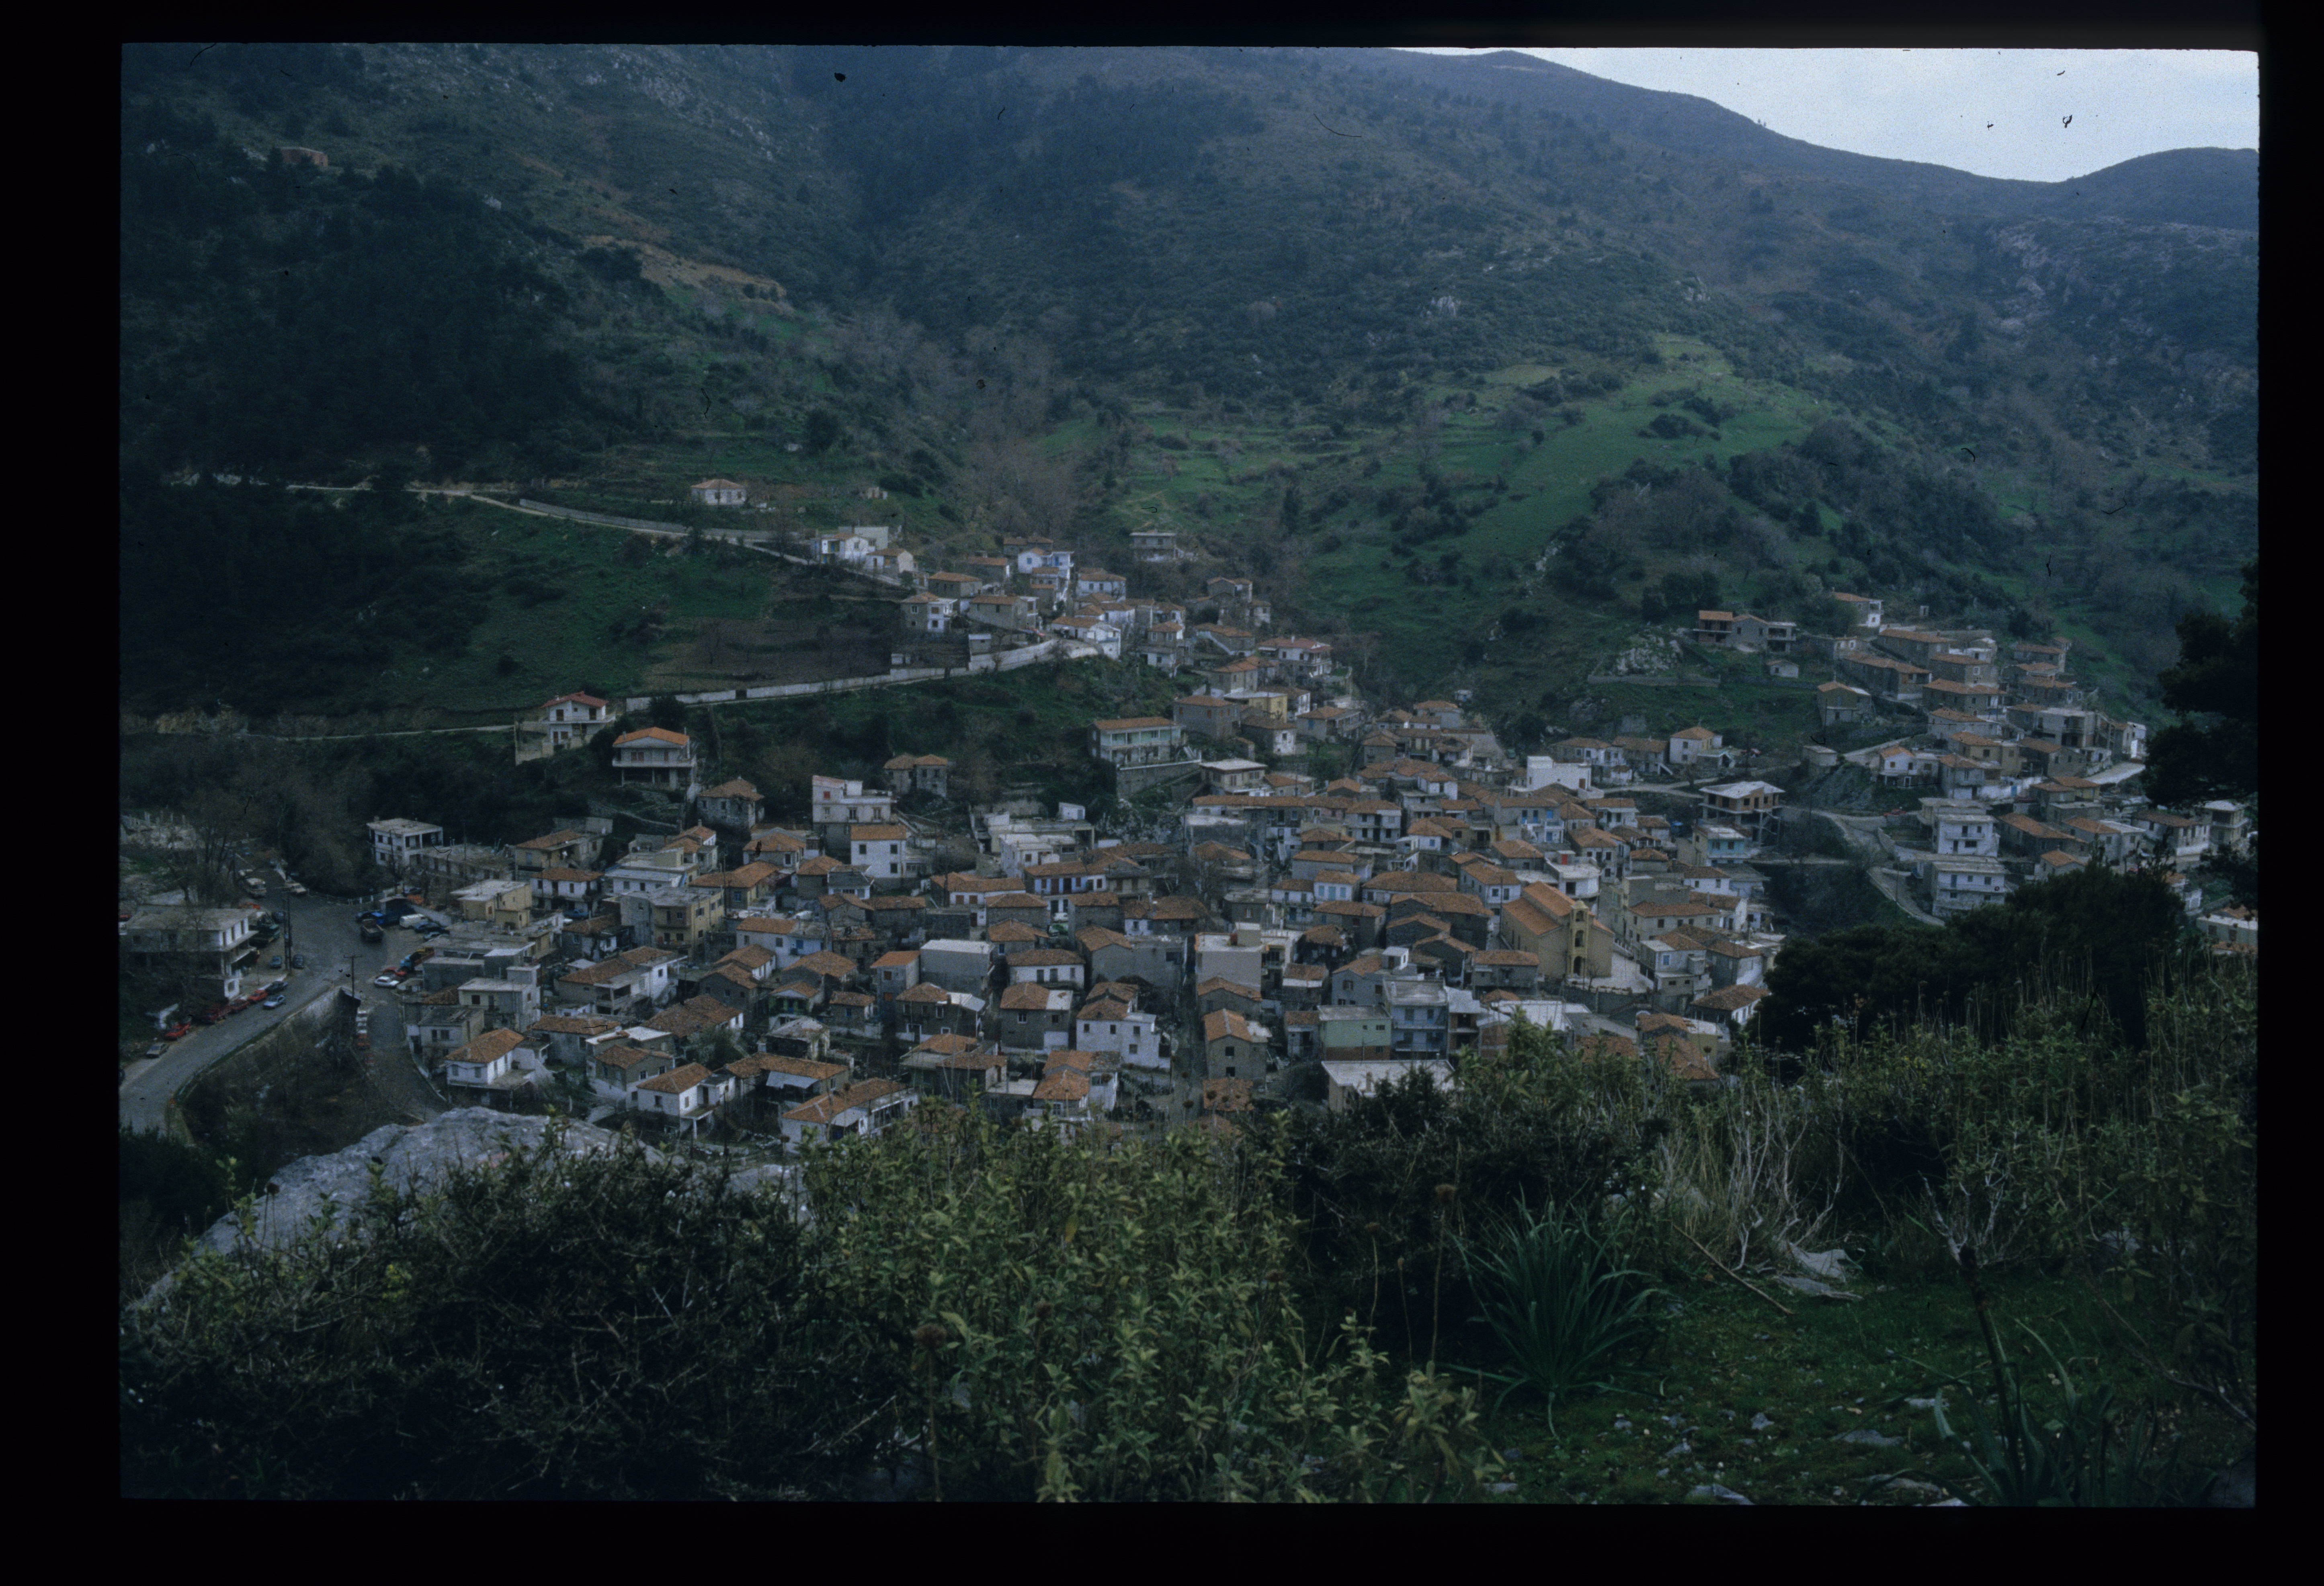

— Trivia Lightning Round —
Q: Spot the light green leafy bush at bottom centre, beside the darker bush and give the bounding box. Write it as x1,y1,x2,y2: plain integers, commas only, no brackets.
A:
806,1109,1490,1500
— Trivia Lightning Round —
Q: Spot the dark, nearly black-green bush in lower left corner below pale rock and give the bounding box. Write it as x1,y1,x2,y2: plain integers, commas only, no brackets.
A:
121,1130,892,1498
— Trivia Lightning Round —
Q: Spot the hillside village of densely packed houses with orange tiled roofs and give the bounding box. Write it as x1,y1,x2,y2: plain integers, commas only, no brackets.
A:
168,479,2256,1144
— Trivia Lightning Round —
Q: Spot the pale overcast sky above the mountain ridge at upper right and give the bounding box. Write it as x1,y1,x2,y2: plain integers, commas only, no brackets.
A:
1404,49,2259,181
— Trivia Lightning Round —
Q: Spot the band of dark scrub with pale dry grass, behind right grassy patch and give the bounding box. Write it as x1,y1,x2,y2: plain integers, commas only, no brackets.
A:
1290,961,2259,1460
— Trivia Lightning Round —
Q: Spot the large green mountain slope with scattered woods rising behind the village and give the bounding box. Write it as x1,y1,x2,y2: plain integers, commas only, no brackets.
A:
121,44,2256,723
